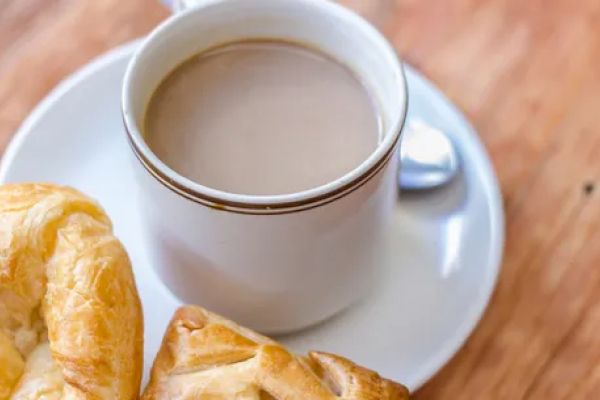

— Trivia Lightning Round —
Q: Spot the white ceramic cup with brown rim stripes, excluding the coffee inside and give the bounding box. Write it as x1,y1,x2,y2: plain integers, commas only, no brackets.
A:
123,0,407,333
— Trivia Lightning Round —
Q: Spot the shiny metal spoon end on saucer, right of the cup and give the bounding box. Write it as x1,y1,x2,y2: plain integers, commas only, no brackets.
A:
399,119,460,190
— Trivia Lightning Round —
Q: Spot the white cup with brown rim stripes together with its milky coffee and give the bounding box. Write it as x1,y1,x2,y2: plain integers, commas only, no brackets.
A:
123,0,407,333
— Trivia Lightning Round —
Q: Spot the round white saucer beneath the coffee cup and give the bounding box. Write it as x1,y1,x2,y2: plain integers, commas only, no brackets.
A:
0,43,504,389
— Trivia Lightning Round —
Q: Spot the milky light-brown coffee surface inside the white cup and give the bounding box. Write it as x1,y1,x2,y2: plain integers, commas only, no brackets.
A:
144,41,381,195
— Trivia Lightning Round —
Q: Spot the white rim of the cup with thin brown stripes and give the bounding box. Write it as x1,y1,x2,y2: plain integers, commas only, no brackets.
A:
121,0,408,214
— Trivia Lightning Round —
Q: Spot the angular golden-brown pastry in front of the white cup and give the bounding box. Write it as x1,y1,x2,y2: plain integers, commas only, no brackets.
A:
142,306,408,400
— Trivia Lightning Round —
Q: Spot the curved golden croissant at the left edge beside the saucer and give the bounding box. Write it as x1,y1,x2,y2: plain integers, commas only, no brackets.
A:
0,184,143,400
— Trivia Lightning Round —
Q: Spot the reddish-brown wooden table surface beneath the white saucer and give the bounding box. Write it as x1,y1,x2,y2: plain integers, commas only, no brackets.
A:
0,0,600,400
